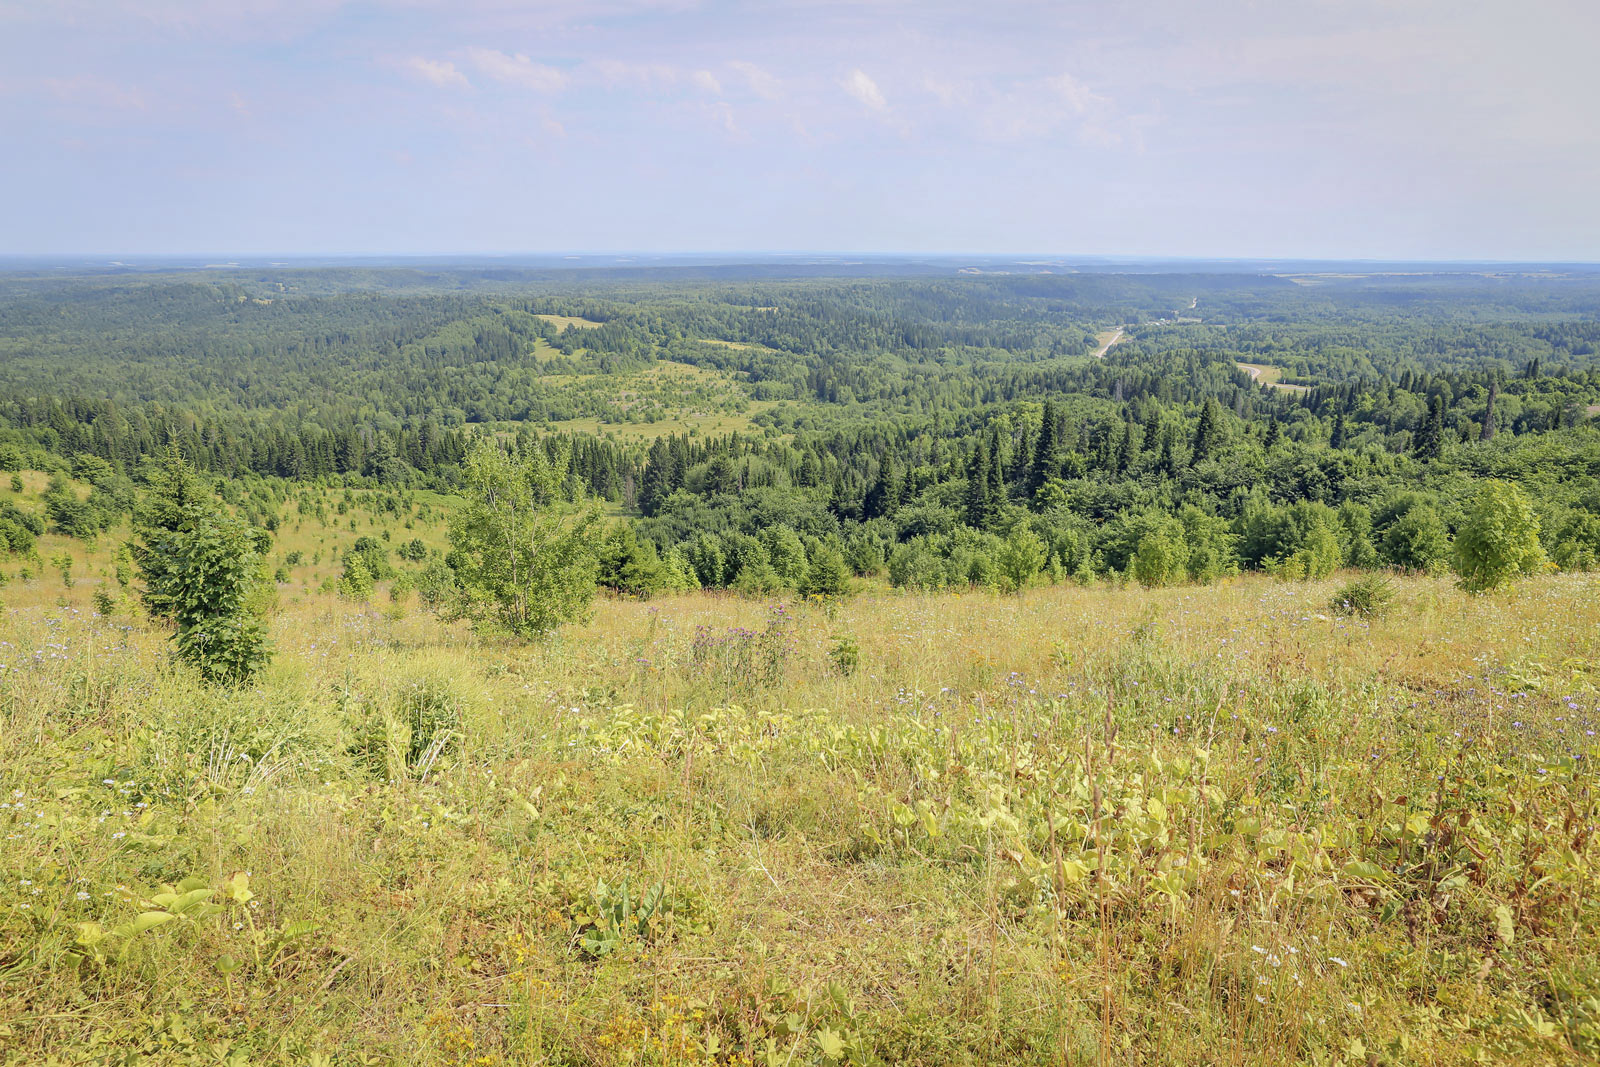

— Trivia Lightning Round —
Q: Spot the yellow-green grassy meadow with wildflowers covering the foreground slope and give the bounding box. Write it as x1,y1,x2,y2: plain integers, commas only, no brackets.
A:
0,493,1600,1067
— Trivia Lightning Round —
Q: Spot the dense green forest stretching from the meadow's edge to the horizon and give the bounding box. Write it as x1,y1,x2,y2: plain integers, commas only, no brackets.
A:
0,259,1600,593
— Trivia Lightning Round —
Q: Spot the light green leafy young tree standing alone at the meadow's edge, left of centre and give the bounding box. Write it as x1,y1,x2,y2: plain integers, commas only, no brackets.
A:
450,442,600,640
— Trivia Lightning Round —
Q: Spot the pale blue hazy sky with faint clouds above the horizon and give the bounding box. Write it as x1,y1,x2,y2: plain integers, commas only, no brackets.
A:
0,0,1600,261
